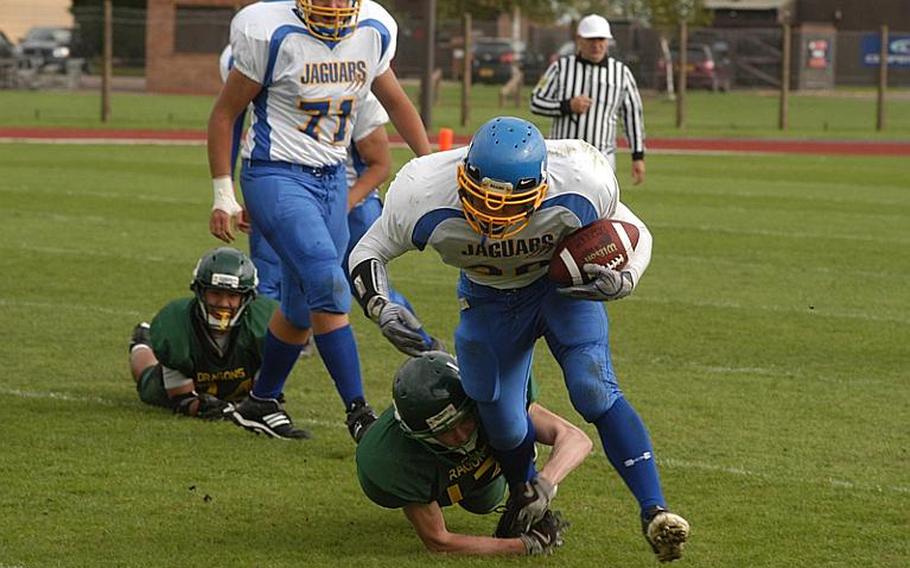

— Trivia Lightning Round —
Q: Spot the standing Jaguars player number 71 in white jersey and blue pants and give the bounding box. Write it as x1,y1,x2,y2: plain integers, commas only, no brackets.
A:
208,0,430,440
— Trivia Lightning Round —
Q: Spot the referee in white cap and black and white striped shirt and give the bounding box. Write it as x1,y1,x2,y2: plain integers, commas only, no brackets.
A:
531,14,645,185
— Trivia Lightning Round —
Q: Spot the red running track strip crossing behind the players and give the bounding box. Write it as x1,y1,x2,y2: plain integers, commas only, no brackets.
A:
0,127,910,156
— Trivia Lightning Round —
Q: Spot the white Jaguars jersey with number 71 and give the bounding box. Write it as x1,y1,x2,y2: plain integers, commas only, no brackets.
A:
231,0,398,166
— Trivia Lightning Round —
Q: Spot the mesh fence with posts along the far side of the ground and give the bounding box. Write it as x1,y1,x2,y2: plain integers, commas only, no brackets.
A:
0,3,910,90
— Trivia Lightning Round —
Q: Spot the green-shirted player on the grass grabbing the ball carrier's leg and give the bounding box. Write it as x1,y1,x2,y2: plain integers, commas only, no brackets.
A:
357,351,593,555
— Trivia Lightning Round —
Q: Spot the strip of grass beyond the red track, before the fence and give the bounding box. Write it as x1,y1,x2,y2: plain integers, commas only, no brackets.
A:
0,83,910,140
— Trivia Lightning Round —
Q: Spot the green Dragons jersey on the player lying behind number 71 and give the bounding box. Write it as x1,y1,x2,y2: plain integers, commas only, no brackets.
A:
151,296,278,400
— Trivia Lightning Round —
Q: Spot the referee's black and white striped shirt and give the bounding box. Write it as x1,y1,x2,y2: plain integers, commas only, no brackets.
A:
531,54,645,160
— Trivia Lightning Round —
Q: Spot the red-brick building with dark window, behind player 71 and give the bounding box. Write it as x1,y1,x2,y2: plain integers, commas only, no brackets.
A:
145,0,254,94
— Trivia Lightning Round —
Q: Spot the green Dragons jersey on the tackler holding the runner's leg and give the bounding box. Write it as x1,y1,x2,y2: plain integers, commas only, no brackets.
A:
357,408,506,513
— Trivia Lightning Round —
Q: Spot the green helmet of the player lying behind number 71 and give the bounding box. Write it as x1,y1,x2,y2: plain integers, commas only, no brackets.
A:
190,247,259,331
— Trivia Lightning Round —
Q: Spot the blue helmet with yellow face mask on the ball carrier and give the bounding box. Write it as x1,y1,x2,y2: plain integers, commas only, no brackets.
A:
458,116,547,239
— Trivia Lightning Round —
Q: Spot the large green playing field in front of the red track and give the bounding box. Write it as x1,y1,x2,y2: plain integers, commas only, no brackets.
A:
0,139,910,568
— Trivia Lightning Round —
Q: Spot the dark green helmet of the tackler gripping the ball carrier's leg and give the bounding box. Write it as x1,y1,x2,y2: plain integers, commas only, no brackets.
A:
392,351,475,442
